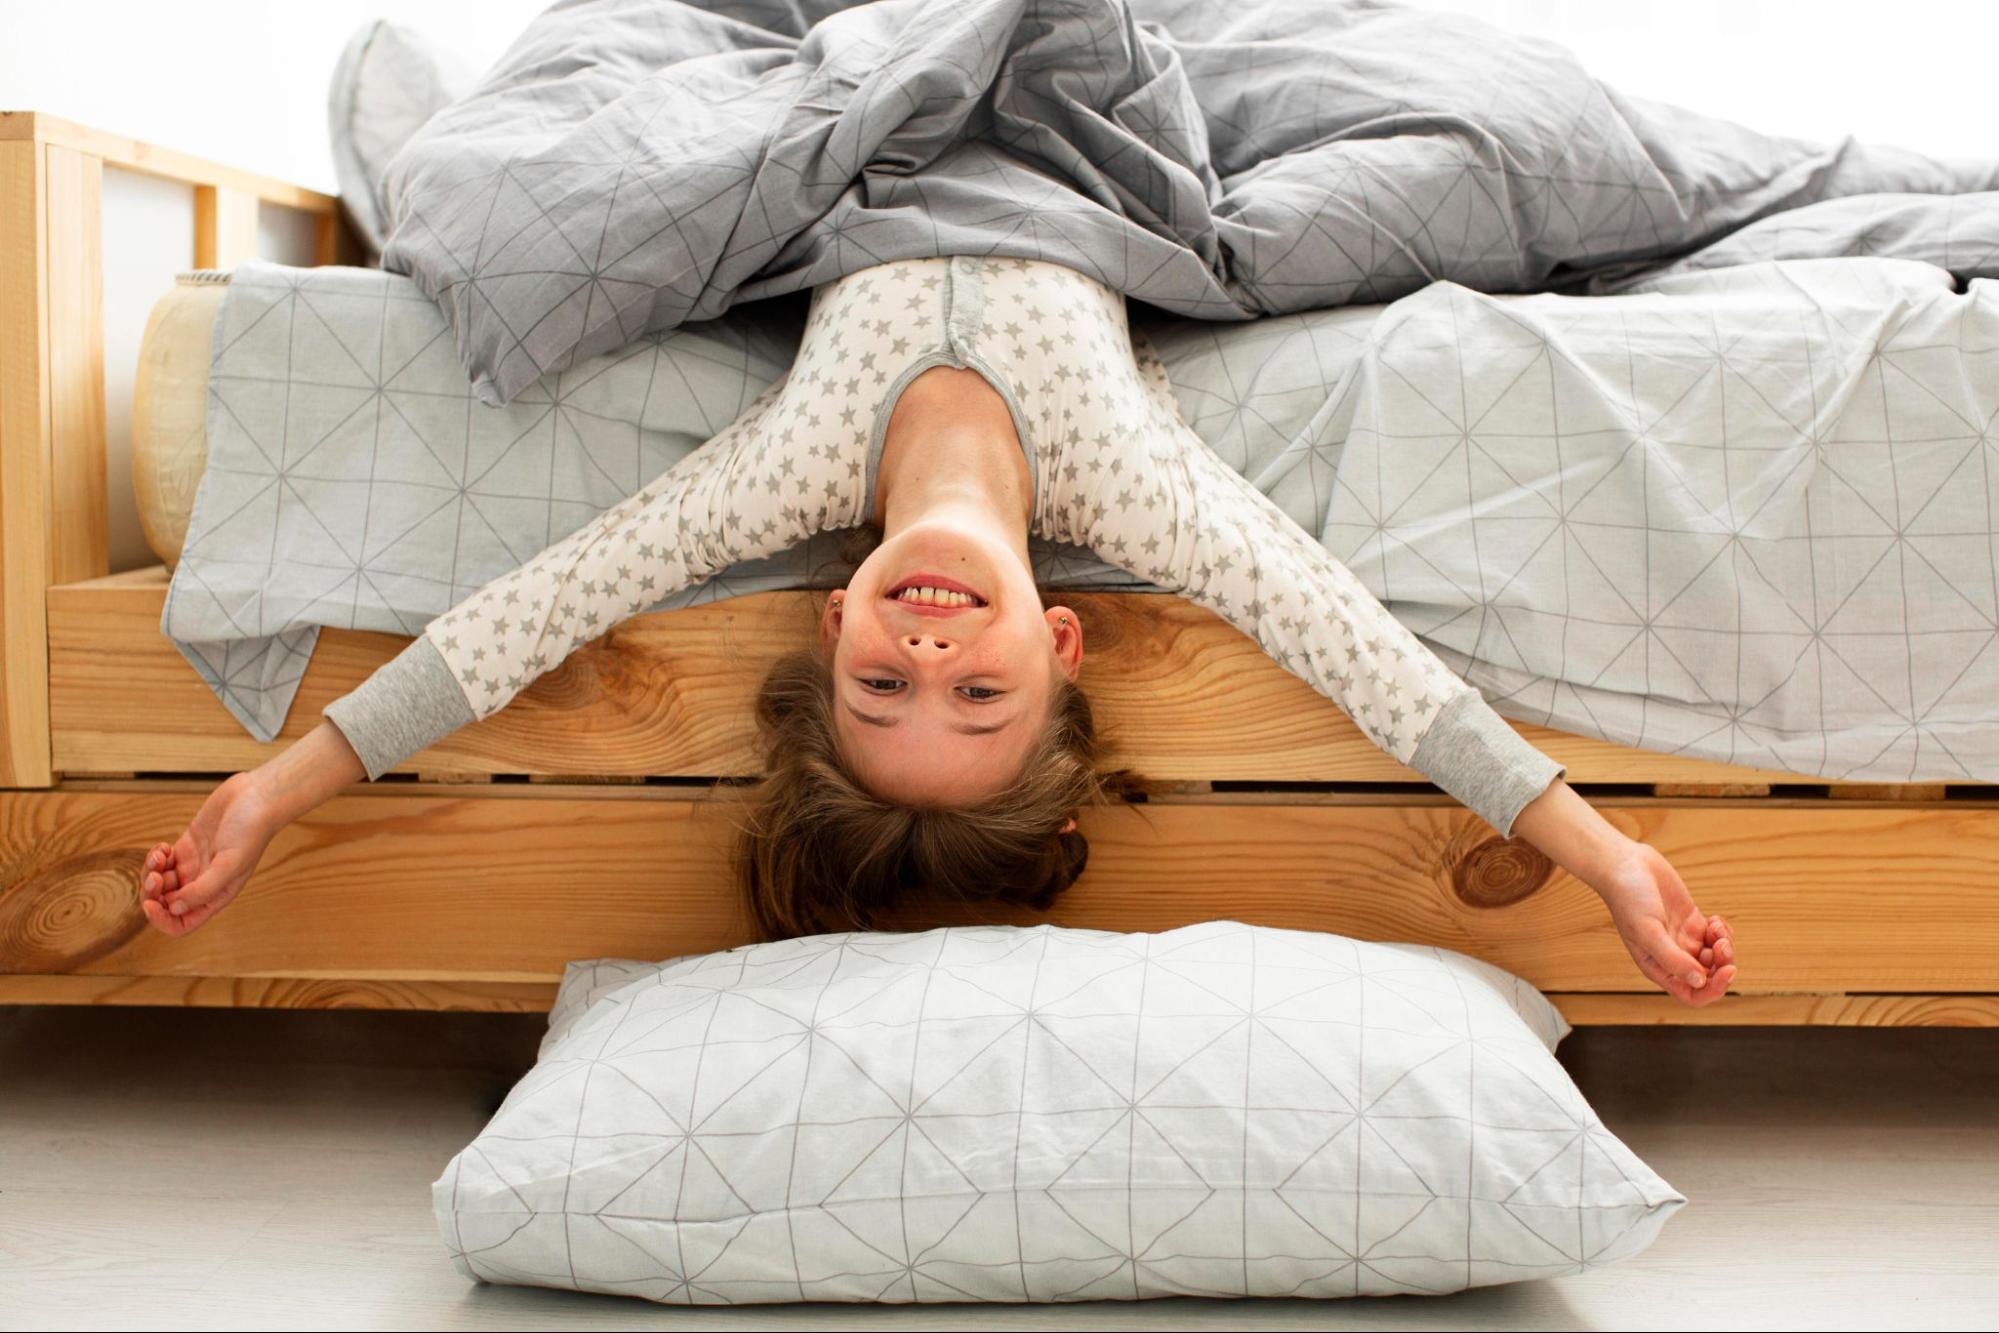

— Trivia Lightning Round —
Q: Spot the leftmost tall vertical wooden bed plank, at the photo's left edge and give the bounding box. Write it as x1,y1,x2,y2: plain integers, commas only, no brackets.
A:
0,140,54,787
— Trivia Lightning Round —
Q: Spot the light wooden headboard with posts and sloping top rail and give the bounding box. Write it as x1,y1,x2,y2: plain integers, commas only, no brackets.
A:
0,112,354,787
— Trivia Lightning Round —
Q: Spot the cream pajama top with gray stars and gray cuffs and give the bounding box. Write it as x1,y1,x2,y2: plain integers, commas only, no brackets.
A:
326,256,1565,833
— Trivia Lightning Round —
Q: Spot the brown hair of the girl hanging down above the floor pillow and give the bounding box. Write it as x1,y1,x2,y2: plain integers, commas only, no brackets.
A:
736,650,1143,939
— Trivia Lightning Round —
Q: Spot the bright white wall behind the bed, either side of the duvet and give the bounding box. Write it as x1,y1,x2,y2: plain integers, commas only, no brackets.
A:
0,0,1999,190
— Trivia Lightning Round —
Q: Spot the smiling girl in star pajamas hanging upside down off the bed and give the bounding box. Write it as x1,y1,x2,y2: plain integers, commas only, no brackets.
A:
142,258,1735,1003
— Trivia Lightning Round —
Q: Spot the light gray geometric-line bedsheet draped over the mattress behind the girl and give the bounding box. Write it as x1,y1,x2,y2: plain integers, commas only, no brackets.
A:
162,258,1999,781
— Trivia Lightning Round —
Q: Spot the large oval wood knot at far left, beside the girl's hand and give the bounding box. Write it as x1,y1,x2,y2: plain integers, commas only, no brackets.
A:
0,851,146,971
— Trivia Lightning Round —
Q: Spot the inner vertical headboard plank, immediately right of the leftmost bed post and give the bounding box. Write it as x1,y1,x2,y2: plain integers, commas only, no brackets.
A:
44,144,110,584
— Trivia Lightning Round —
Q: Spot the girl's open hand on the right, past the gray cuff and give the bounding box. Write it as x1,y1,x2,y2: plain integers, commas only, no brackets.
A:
1591,841,1735,1007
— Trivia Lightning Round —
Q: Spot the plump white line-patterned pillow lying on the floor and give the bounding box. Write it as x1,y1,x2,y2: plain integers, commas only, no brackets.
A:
432,921,1685,1305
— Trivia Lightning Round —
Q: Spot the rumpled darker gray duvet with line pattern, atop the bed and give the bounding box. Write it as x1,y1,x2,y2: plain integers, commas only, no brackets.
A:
384,0,1999,404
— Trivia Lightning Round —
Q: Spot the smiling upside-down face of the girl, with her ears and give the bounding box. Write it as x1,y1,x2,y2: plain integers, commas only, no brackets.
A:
820,522,1083,805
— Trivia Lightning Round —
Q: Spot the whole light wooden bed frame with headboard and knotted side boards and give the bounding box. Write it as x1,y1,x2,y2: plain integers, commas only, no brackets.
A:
0,114,1999,1025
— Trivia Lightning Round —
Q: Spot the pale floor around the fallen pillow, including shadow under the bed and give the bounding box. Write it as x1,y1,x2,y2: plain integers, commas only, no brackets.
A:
0,1007,1999,1331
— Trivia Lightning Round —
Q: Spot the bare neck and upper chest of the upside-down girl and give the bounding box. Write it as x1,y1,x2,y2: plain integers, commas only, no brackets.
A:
874,366,1033,562
